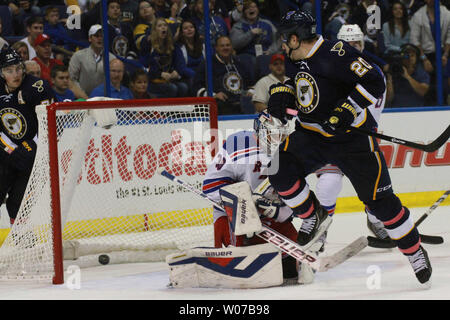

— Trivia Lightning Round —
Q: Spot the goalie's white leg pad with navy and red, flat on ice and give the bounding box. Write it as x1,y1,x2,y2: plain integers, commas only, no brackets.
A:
166,243,283,289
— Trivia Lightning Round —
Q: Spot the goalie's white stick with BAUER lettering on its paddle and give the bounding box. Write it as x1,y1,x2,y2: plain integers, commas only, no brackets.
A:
157,168,368,272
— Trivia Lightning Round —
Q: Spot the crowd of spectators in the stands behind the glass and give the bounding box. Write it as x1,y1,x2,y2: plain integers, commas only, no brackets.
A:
0,0,450,114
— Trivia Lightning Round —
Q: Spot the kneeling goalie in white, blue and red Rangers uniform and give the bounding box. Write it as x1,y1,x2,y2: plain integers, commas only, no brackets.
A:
166,113,334,288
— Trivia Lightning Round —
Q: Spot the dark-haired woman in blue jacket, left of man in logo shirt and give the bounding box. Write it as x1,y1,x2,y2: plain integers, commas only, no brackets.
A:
175,20,204,96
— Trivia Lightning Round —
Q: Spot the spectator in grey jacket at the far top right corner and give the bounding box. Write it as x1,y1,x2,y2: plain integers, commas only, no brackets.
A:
410,0,450,66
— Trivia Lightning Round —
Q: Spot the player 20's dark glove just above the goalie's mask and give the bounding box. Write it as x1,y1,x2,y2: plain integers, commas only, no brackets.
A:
267,83,296,124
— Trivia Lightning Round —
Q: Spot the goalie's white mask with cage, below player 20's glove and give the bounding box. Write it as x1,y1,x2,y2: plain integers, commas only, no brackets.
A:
253,112,295,156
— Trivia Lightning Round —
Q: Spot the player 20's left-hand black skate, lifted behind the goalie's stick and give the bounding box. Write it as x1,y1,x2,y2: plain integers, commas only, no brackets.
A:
297,192,332,251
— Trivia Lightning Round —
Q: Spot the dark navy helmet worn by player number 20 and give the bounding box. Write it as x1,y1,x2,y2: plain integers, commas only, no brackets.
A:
278,10,317,41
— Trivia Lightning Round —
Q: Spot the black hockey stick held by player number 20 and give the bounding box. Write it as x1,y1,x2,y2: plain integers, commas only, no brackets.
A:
286,108,450,152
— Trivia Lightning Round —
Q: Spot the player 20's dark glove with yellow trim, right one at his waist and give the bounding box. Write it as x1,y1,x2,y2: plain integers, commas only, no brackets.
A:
322,100,357,135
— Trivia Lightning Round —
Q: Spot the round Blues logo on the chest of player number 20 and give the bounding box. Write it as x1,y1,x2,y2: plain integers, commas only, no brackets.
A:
295,71,319,113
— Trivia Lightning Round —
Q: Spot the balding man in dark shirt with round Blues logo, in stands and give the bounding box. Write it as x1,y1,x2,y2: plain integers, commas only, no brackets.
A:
194,36,255,115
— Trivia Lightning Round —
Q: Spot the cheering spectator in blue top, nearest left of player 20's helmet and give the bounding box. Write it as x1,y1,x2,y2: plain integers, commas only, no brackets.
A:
230,0,280,59
